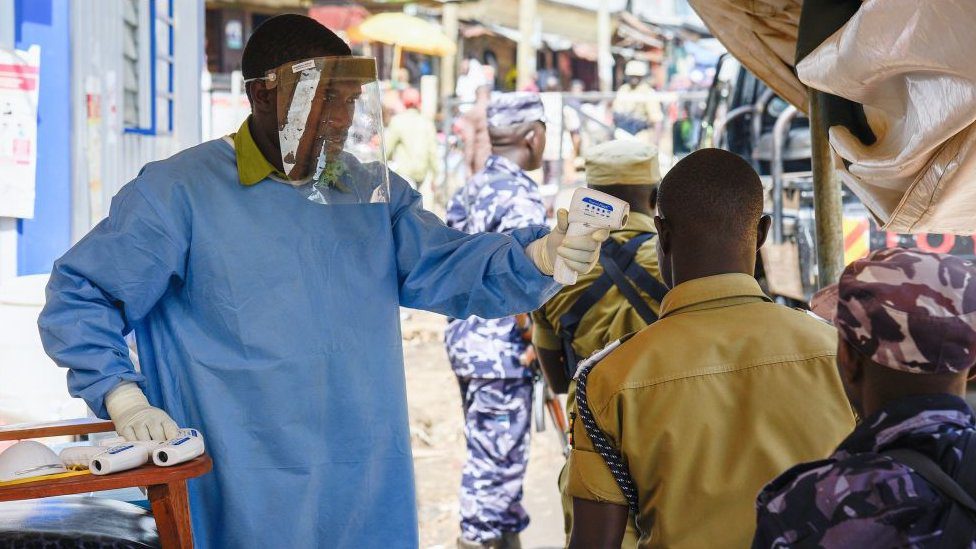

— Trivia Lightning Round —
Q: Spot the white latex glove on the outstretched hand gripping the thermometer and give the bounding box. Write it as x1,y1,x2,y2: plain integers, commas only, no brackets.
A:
525,208,610,276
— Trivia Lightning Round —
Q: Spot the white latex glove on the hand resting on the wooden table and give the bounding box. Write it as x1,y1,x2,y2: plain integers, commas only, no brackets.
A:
105,381,180,441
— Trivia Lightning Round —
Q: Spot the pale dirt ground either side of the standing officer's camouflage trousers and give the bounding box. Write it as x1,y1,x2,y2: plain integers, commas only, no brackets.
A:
403,310,564,549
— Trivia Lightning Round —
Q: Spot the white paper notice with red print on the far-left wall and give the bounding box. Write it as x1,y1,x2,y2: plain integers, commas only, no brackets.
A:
0,46,40,219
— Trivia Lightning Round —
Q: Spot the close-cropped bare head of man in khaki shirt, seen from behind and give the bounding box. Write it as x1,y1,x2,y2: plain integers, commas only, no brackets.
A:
655,149,769,286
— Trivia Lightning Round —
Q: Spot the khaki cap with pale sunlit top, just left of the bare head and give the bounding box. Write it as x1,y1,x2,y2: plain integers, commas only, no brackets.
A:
586,139,661,185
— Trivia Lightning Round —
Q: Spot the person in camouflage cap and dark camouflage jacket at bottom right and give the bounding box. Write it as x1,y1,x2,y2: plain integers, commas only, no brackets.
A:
753,249,976,548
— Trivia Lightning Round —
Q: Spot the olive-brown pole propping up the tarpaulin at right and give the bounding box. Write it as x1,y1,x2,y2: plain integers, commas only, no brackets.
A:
809,90,844,288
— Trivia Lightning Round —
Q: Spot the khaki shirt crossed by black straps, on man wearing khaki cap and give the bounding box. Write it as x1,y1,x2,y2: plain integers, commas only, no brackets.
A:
532,212,661,358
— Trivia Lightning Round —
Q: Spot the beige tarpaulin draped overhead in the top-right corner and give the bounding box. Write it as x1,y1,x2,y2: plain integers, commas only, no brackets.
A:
690,0,976,234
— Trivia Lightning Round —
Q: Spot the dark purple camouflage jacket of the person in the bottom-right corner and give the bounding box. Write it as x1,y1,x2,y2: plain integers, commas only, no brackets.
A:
753,395,976,548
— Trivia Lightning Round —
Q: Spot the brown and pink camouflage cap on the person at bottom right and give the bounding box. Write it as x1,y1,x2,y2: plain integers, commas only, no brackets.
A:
810,248,976,374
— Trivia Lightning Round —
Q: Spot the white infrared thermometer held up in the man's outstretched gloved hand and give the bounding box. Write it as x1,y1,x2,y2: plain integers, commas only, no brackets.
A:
553,188,630,285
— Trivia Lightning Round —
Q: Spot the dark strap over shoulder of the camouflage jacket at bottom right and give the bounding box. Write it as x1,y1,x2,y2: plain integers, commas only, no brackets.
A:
881,436,976,548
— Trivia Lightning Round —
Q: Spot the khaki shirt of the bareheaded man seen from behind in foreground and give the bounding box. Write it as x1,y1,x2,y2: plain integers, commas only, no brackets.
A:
568,274,854,548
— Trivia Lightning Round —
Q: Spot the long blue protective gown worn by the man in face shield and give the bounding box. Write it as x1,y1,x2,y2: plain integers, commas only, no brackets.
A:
39,140,557,548
